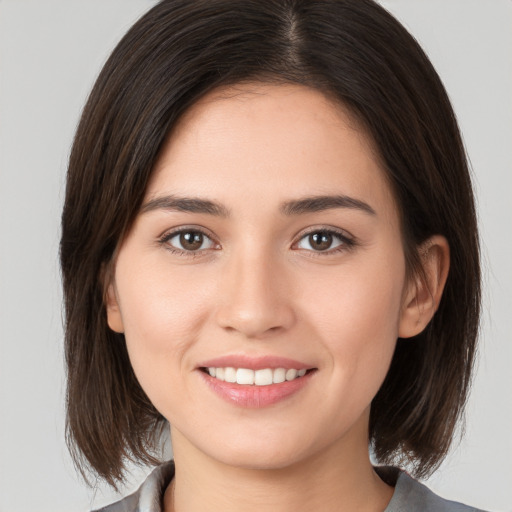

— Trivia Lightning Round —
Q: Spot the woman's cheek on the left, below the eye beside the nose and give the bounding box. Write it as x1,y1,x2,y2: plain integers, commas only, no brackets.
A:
116,258,214,408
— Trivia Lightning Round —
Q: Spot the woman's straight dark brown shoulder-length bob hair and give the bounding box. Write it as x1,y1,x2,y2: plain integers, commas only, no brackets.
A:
60,0,480,486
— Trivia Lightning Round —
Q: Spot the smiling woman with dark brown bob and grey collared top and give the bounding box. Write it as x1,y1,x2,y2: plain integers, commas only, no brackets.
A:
61,0,480,512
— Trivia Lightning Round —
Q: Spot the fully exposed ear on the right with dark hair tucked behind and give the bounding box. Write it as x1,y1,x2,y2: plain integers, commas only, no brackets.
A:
398,235,450,338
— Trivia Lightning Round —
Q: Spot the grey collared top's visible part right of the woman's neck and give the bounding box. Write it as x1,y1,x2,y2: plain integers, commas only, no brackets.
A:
385,471,484,512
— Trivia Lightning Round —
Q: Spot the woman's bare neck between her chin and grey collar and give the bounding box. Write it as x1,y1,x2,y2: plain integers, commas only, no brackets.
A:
164,424,393,512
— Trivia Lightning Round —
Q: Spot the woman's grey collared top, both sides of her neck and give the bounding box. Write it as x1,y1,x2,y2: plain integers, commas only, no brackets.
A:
95,461,484,512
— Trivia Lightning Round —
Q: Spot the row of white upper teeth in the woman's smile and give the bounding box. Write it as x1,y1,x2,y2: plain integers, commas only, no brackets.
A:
207,367,307,386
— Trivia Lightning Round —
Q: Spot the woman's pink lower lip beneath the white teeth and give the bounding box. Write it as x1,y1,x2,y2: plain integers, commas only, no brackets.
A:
199,370,315,409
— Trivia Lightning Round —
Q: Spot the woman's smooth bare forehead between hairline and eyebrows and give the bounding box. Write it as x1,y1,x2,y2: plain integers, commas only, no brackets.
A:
146,83,393,221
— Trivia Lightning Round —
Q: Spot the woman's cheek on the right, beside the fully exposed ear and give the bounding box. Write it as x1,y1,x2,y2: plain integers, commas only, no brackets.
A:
304,254,405,392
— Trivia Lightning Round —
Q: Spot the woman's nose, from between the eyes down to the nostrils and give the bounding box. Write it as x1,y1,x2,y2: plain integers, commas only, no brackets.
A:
217,249,295,339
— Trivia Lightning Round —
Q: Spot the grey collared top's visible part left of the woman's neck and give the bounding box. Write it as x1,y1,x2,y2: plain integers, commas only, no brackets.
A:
93,461,174,512
